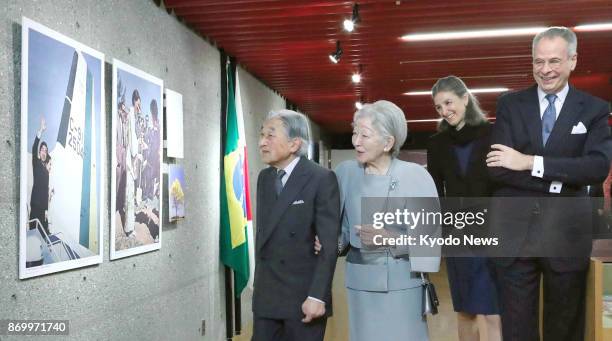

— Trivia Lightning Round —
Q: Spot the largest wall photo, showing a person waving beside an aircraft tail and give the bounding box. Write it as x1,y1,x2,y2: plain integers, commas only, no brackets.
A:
19,18,106,279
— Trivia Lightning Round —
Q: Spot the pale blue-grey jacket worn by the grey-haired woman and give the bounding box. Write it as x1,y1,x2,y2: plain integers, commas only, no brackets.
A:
335,159,440,292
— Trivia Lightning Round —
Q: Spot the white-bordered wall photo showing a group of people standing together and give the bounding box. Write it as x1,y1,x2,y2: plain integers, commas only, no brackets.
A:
110,59,163,259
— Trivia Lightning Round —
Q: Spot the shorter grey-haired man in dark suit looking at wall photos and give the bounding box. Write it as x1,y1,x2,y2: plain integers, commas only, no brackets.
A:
252,110,340,341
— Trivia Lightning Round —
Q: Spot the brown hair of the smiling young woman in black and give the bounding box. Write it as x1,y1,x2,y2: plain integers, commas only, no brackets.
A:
431,75,487,131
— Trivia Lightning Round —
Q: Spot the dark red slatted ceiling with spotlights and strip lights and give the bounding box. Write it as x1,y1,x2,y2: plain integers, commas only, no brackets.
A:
164,0,612,132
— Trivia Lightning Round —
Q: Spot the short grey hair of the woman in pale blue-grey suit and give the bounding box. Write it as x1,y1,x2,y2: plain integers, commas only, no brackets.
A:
353,100,408,157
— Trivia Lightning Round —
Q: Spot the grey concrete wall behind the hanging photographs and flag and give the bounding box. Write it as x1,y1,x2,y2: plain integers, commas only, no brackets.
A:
0,0,298,340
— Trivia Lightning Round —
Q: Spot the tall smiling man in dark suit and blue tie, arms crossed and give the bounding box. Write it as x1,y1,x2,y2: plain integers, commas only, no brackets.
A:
487,27,611,341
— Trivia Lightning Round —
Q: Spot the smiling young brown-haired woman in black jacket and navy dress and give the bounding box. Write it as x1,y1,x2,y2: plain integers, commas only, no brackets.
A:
427,76,501,341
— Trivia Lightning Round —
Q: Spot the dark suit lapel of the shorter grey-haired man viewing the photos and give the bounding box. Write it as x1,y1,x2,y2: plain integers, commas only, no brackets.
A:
259,158,311,248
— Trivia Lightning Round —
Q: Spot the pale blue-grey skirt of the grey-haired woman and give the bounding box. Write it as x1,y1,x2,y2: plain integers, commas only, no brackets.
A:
346,287,429,341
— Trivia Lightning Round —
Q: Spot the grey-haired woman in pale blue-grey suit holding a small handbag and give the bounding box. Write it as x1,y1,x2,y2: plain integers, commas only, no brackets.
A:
336,101,440,341
